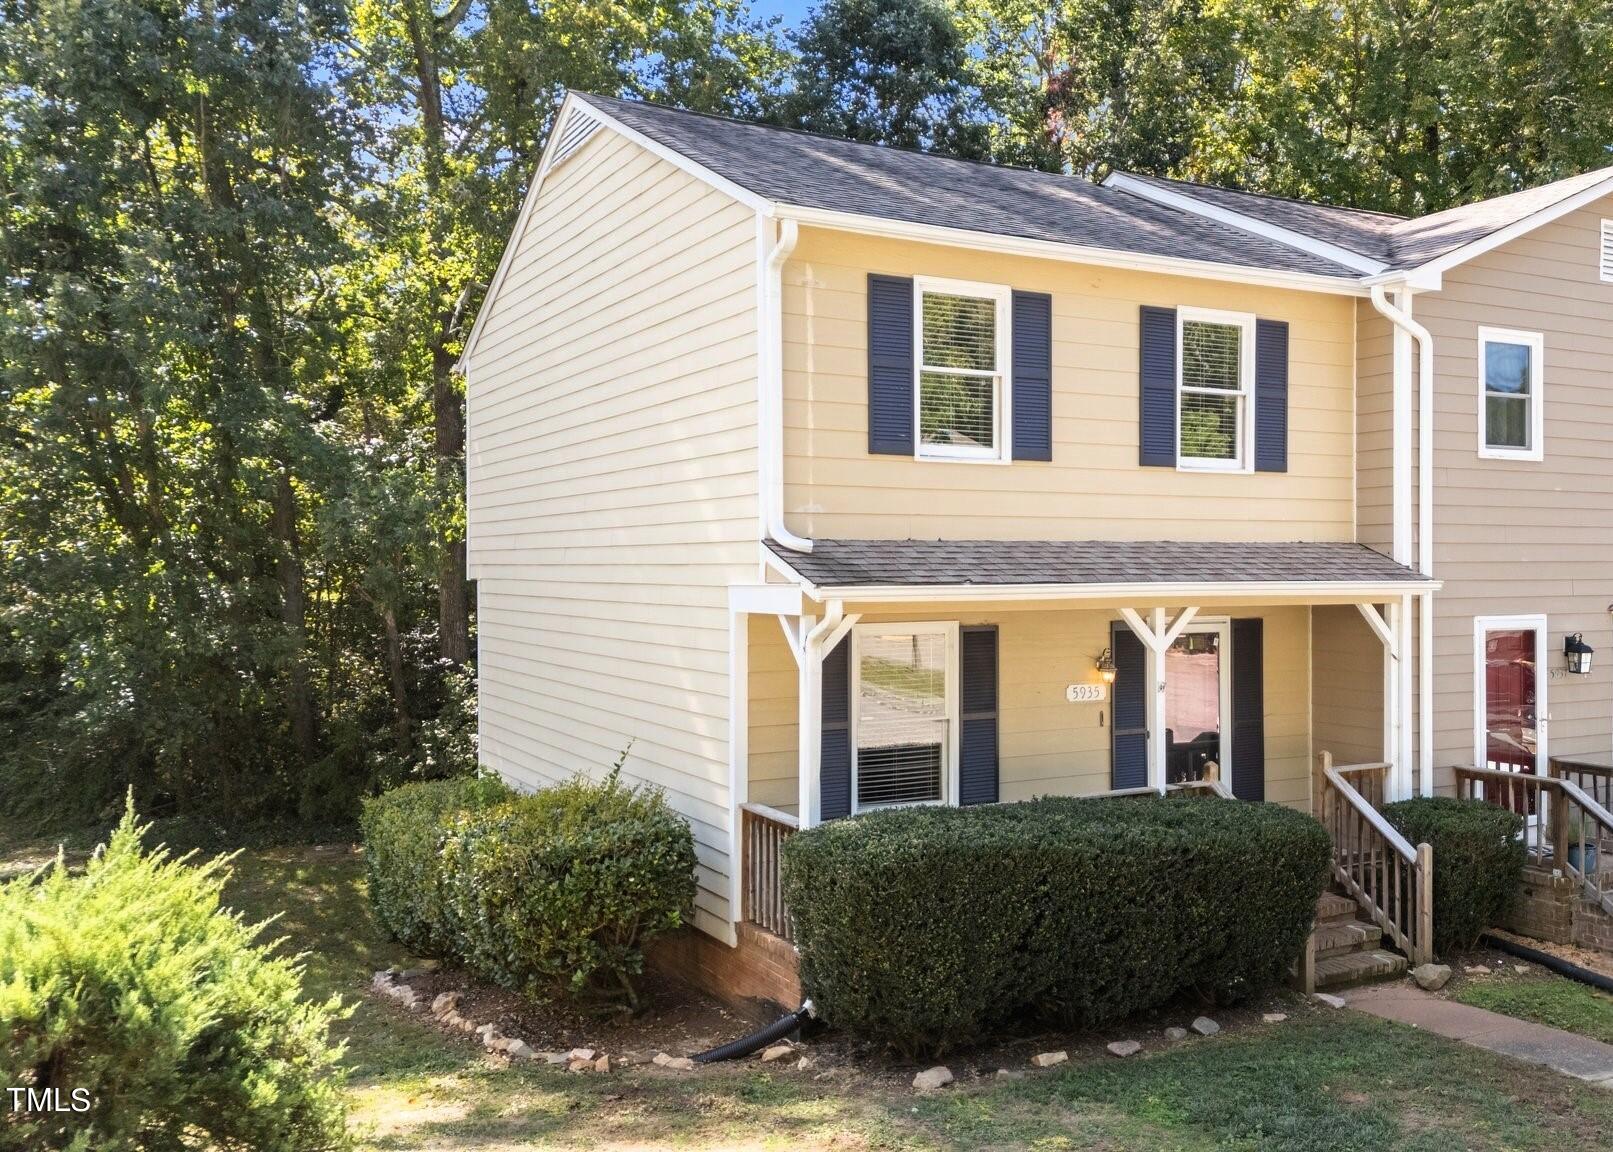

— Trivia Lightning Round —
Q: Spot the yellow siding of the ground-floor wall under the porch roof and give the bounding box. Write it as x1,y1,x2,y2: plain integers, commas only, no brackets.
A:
750,603,1316,810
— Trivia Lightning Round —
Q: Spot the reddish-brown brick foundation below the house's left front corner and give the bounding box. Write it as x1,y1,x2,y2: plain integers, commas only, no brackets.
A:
647,923,802,1020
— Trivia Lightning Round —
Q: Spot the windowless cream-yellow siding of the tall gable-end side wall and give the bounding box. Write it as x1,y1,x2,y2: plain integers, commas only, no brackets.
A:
466,129,758,936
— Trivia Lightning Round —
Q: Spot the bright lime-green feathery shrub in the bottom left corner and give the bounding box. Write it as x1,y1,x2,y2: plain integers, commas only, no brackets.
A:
0,808,348,1152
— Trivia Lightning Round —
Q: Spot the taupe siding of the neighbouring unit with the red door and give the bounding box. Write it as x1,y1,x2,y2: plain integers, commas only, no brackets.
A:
1416,197,1613,791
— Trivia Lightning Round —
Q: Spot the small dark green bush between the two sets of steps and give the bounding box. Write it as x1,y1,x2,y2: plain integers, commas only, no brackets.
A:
1384,795,1526,955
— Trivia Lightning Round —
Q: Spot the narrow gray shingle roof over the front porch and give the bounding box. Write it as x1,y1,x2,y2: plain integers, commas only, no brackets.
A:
768,541,1424,587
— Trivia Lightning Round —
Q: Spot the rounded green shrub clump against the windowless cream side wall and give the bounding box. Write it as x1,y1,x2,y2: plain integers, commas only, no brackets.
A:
365,765,695,1007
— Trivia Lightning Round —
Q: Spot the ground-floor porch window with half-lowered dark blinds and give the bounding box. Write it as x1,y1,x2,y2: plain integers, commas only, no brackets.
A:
852,623,958,812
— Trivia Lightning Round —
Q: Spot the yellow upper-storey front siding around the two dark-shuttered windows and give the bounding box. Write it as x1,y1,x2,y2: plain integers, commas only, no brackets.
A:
784,229,1355,541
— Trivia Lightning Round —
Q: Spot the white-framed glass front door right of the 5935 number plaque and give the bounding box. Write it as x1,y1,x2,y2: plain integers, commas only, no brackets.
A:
1165,620,1232,786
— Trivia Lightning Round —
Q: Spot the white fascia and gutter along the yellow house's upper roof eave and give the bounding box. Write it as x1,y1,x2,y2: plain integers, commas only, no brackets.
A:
776,203,1368,297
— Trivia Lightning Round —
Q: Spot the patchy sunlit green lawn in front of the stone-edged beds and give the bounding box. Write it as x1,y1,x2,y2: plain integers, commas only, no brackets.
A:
198,849,1613,1152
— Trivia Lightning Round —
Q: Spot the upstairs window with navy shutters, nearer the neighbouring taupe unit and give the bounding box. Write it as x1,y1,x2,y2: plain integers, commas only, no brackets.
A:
1176,308,1255,471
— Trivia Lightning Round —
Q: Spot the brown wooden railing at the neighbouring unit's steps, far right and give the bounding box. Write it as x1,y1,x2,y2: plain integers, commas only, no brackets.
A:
1457,760,1613,915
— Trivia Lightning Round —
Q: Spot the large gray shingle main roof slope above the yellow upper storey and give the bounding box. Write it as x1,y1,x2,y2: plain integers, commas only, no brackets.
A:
577,94,1355,279
